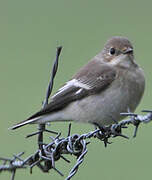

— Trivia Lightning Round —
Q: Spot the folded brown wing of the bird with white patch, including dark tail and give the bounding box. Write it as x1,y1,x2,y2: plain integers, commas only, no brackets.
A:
11,61,116,129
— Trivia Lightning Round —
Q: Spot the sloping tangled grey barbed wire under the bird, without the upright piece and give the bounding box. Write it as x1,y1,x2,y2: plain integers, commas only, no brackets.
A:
0,111,152,180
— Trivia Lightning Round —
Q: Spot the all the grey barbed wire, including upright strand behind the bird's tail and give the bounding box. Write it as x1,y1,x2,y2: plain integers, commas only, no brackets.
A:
0,47,152,180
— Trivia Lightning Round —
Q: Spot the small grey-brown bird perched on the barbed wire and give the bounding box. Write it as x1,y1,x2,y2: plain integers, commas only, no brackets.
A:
10,36,145,130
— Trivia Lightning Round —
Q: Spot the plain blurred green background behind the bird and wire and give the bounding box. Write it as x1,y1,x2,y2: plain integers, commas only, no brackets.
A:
0,0,152,180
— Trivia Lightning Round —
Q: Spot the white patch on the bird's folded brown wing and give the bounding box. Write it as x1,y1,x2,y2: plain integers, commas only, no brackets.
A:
52,79,91,98
